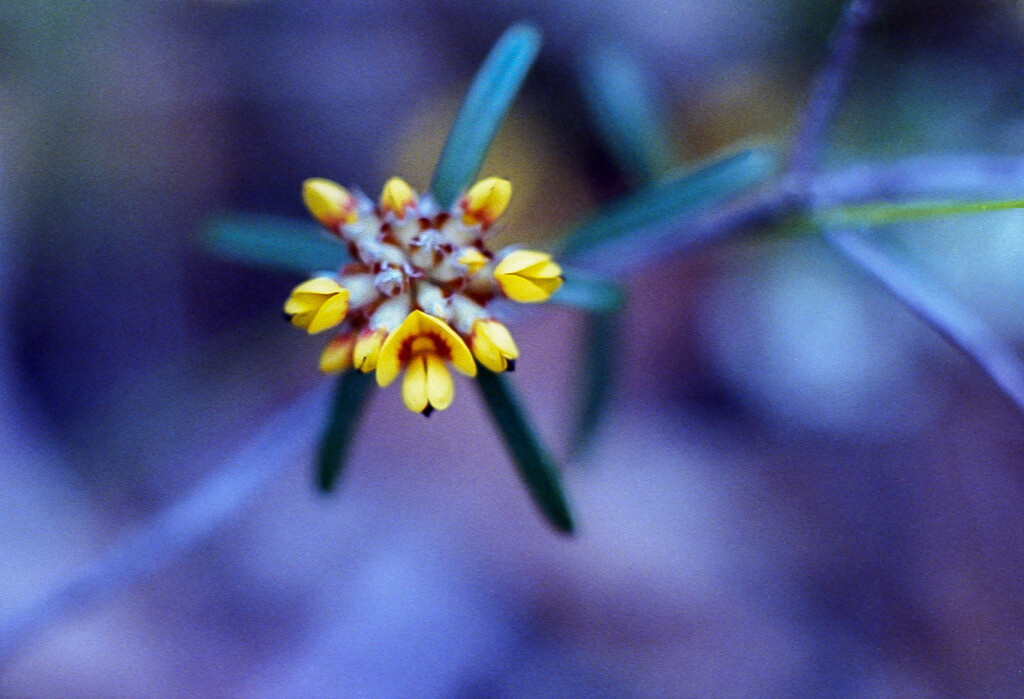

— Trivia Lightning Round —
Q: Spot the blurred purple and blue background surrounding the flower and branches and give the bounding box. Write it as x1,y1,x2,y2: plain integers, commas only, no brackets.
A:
0,0,1024,697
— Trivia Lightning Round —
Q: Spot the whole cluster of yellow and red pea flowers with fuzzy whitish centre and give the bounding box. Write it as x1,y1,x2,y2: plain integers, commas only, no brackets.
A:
285,177,562,416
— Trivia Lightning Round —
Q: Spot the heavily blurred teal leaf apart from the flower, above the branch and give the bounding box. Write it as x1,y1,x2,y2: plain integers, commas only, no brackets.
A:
582,47,674,182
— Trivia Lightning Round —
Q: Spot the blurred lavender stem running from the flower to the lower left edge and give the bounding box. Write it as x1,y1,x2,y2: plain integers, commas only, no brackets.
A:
0,386,327,668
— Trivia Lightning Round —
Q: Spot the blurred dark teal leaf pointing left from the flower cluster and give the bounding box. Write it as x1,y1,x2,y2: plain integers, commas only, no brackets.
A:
201,213,348,274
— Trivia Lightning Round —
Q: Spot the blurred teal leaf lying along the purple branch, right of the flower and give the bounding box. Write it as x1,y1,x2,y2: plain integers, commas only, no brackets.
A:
559,148,777,257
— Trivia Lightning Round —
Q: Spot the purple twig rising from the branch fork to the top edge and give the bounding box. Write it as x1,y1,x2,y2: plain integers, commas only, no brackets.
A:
788,0,874,176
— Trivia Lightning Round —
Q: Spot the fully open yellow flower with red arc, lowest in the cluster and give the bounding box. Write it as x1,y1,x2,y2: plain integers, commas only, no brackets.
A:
377,310,476,416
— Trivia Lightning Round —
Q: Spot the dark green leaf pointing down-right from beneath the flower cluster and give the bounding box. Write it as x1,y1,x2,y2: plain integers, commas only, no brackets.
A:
476,366,574,534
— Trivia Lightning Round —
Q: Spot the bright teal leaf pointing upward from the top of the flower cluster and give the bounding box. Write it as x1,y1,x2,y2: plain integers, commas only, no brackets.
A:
430,25,541,209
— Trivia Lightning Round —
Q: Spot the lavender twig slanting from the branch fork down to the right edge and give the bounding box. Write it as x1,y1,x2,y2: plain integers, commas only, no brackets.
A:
825,231,1024,412
